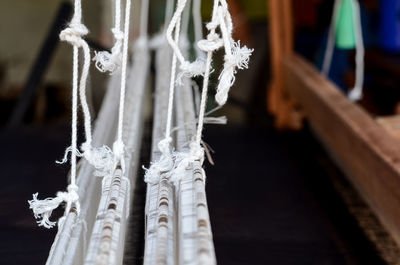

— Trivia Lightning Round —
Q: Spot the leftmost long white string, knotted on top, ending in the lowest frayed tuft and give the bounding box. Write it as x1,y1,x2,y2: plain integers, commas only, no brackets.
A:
28,0,90,228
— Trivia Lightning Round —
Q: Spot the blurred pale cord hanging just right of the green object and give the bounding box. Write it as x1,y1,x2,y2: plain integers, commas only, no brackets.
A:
348,0,364,101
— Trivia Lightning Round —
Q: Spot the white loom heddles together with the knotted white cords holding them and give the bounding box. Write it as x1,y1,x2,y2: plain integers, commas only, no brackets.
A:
29,0,252,265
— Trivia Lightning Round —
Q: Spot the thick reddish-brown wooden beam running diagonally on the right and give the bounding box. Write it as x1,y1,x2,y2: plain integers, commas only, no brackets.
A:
284,55,400,245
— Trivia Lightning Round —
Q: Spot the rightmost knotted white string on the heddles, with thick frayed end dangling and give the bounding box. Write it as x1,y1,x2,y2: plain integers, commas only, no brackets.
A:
171,0,253,183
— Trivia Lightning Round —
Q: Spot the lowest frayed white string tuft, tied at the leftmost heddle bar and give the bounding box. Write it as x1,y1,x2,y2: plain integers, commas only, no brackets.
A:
28,184,80,229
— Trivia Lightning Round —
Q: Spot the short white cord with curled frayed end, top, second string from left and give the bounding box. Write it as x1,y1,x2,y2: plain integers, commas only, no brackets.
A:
93,0,124,74
